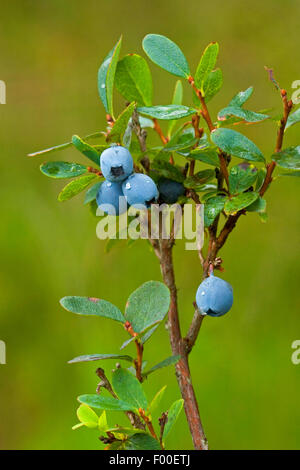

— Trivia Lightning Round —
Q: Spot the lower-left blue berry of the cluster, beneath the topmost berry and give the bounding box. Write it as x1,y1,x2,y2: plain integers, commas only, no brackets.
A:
96,181,127,215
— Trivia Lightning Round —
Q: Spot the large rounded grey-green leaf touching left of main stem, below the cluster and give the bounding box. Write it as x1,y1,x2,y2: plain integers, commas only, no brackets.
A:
125,281,170,333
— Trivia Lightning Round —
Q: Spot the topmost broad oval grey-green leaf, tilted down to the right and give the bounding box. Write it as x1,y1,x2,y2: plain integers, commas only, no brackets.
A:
143,34,190,78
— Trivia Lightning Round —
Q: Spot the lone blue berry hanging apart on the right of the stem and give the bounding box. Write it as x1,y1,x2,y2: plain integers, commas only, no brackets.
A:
196,273,233,317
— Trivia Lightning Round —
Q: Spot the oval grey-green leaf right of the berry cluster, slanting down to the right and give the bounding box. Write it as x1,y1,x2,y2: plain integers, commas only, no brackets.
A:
211,128,265,162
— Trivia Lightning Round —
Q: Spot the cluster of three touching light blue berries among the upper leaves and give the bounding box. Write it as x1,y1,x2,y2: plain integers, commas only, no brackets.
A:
96,145,159,215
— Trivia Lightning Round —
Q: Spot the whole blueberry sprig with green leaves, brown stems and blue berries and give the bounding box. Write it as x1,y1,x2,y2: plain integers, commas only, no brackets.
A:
31,34,300,450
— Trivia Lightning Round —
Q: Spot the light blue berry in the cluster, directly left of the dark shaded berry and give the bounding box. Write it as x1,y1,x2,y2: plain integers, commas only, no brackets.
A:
122,173,158,208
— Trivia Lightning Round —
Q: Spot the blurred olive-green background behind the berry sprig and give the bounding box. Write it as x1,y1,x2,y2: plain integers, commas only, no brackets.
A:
0,0,300,449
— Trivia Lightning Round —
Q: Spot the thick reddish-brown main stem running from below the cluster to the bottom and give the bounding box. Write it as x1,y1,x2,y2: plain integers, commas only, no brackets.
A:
160,239,208,450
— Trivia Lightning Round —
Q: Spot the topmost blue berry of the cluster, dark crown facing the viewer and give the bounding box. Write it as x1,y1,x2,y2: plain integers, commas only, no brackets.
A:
100,145,133,181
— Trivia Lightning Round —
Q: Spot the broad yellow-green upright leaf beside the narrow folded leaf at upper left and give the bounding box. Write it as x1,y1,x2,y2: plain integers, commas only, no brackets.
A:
115,54,152,106
